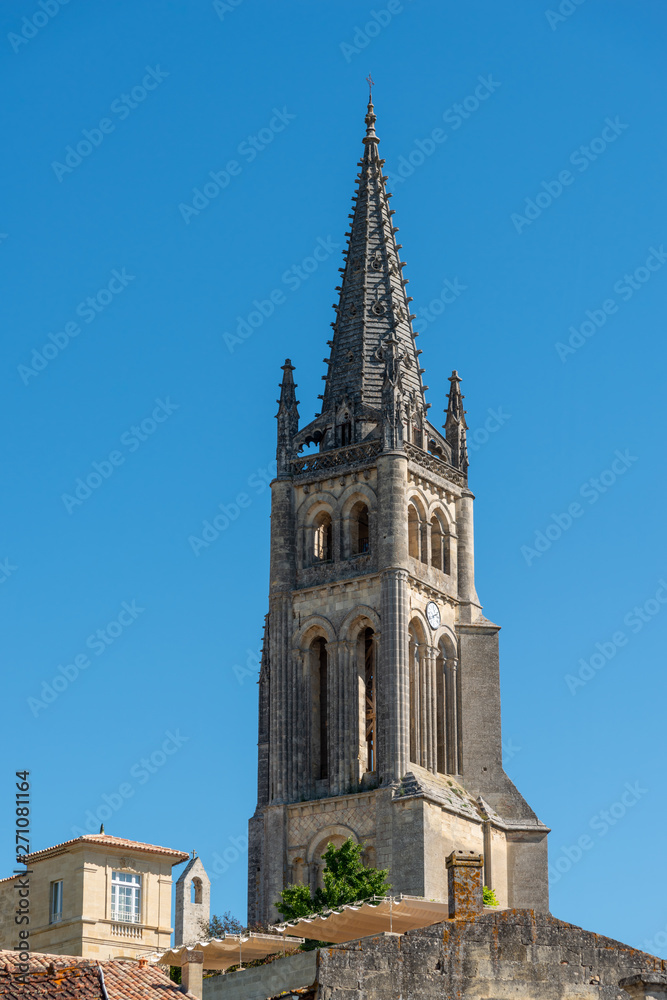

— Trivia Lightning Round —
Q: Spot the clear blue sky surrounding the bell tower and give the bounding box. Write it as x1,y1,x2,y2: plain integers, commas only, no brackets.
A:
0,0,667,955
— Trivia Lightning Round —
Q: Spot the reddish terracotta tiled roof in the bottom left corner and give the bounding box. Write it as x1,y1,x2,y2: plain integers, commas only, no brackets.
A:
0,951,198,1000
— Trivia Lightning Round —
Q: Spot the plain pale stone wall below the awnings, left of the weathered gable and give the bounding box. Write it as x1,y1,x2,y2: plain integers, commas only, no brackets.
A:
204,951,319,1000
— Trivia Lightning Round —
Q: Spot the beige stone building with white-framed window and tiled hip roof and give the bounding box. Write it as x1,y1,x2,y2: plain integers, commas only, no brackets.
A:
0,833,188,960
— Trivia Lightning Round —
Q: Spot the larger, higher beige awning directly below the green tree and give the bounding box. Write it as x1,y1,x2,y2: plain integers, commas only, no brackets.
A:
274,896,449,944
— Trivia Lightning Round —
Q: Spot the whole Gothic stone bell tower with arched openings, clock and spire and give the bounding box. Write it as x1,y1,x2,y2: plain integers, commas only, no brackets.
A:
248,94,549,924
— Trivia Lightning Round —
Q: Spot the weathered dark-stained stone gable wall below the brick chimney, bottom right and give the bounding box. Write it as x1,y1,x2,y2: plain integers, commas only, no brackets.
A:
317,910,666,1000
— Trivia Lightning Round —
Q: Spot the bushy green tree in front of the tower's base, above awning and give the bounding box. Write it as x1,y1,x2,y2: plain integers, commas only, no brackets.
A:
275,837,391,920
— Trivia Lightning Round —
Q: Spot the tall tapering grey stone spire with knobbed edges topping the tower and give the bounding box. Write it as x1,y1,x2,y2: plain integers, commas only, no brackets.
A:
322,100,426,417
